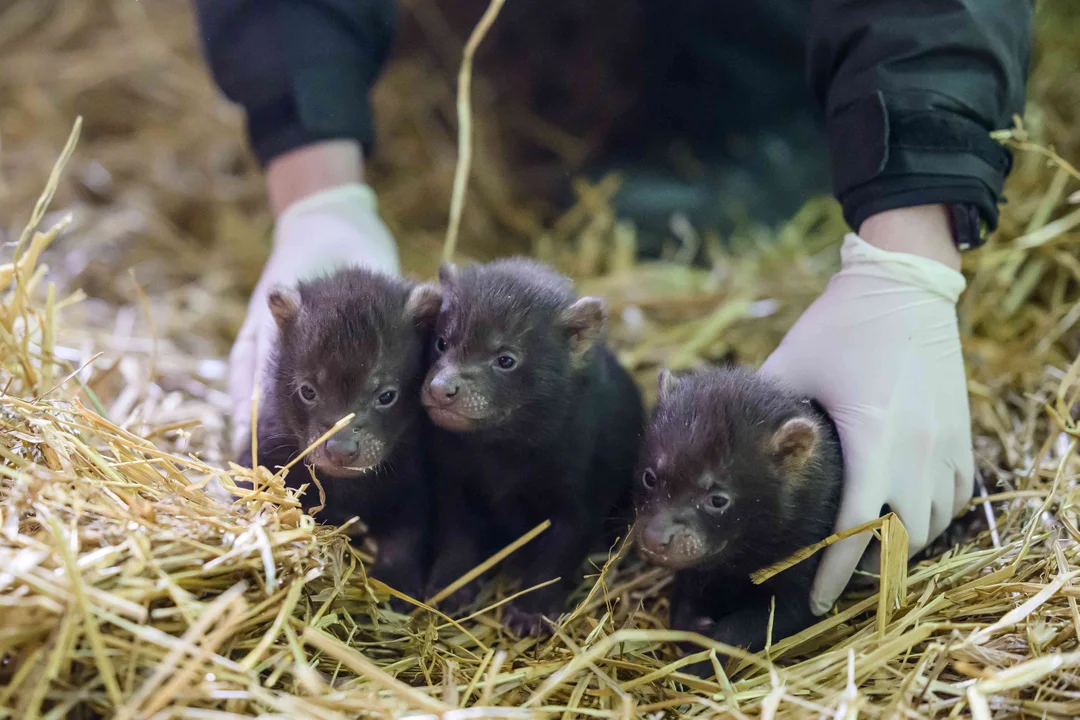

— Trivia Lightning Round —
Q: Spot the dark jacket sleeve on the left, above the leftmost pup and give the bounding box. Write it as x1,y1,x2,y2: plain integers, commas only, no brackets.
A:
195,0,395,164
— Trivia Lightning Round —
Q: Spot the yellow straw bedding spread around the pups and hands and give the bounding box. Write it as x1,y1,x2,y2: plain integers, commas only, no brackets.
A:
0,0,1080,720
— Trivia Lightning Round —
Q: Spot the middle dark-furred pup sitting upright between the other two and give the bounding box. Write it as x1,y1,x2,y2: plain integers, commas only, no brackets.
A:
421,258,645,635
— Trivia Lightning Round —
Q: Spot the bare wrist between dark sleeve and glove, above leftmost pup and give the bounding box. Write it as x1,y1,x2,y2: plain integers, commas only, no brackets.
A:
266,139,364,218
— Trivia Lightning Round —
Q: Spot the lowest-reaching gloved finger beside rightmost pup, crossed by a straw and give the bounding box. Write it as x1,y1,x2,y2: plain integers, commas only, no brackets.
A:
810,440,885,615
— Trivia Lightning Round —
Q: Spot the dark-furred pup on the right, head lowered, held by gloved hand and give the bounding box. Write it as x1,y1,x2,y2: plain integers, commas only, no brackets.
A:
634,368,843,674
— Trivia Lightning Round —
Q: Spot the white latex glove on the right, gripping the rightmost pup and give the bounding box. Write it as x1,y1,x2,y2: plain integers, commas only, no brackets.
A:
761,233,974,615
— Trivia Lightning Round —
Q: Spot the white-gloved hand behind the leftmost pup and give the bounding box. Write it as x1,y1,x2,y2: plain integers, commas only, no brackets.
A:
229,182,401,454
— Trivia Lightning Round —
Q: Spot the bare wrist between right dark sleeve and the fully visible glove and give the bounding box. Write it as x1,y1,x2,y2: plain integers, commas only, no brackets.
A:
859,205,960,271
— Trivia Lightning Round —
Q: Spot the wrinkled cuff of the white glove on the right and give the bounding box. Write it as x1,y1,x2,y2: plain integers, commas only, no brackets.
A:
840,232,968,304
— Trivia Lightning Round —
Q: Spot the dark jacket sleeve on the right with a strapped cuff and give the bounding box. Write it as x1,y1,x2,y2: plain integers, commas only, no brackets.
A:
807,0,1034,243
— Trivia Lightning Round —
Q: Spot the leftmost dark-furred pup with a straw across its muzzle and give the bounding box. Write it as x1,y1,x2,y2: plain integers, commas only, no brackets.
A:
239,268,438,598
